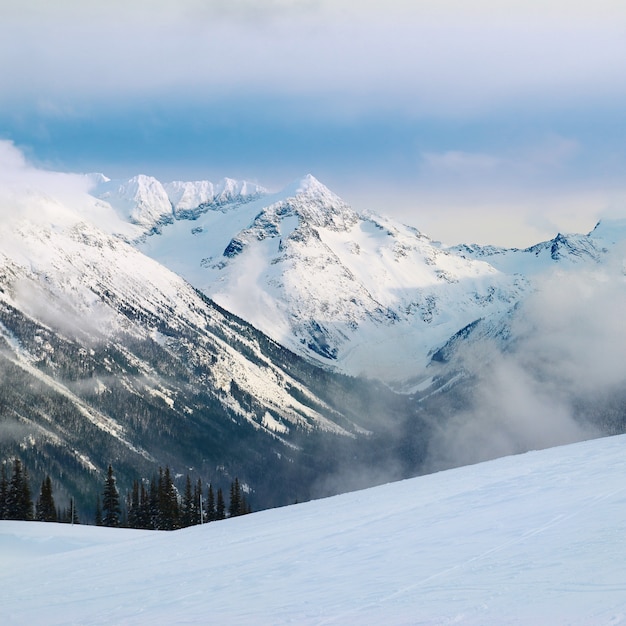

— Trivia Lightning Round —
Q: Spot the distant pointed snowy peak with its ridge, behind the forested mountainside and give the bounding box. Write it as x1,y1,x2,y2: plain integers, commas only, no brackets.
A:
113,175,623,391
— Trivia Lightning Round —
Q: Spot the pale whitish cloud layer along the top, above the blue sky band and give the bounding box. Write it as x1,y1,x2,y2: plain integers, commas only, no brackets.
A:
0,0,626,115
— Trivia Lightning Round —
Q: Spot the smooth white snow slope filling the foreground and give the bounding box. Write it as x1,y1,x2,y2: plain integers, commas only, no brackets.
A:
0,436,626,626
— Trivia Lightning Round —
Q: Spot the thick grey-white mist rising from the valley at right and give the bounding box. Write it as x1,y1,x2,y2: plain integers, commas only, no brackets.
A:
429,260,626,468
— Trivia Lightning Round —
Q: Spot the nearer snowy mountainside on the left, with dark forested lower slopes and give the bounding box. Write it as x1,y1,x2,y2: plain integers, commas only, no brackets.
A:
0,181,420,506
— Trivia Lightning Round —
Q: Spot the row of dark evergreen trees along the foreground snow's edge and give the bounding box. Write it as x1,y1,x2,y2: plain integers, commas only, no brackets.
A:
0,458,252,530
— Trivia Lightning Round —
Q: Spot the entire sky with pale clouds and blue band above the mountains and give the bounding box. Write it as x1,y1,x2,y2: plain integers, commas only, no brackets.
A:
0,0,626,245
